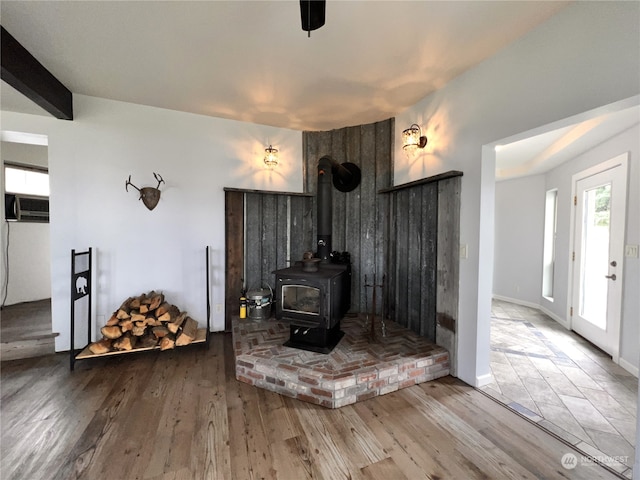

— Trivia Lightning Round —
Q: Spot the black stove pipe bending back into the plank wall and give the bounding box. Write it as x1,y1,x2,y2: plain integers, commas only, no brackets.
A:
317,155,361,263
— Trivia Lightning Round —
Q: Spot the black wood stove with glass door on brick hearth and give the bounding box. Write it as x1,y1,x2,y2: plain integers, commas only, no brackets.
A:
274,263,351,353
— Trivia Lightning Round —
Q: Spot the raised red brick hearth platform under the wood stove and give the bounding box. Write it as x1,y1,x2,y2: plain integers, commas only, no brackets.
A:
233,317,449,408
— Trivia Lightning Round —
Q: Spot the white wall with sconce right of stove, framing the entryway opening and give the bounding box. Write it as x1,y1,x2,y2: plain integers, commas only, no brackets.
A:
395,2,640,385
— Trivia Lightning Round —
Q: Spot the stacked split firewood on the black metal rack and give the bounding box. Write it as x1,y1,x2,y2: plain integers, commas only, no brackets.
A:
89,291,198,355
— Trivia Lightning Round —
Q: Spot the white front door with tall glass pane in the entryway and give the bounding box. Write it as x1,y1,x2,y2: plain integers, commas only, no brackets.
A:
570,153,627,362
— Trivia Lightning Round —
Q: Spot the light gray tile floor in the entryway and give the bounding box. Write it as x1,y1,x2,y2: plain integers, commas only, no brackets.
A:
483,300,638,478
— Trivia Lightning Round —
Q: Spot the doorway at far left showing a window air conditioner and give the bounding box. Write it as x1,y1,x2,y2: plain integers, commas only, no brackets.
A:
0,131,57,361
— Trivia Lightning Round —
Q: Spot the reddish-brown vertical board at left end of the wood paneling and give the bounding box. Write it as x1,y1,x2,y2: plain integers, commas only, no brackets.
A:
224,192,244,331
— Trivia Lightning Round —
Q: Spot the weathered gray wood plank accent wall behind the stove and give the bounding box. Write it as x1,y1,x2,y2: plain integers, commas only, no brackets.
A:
225,119,462,374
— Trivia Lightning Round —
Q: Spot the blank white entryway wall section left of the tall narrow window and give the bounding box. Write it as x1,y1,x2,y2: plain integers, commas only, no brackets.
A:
493,175,545,305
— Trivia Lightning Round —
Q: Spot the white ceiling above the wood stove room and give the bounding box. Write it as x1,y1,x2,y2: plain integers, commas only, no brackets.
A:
0,0,568,130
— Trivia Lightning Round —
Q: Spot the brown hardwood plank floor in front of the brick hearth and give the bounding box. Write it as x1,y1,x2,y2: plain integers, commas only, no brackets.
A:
0,334,617,480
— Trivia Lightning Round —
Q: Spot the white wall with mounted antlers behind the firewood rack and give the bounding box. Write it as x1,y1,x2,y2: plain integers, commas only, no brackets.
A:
2,95,302,351
